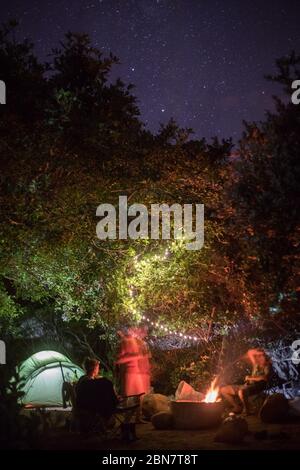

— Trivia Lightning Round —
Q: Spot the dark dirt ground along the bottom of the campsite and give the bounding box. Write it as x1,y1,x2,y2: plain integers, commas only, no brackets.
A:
40,417,300,450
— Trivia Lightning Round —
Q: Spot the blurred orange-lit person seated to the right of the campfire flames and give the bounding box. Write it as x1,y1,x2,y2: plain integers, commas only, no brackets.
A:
220,348,271,415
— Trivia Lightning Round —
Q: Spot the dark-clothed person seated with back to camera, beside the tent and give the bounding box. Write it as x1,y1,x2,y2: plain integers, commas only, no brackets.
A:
76,357,118,420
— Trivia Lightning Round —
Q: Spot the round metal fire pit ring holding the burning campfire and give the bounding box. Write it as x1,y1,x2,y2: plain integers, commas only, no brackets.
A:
171,400,223,429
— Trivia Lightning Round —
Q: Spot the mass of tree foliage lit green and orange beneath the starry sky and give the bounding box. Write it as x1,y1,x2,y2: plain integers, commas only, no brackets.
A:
0,25,300,396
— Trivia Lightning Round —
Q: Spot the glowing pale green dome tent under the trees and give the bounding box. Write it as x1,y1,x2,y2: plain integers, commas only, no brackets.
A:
18,351,84,406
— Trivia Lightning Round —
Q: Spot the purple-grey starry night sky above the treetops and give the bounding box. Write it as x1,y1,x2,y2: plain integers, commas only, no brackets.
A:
0,0,300,141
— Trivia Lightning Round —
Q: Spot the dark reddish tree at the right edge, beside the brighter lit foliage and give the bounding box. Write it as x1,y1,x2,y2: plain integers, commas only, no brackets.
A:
234,53,300,329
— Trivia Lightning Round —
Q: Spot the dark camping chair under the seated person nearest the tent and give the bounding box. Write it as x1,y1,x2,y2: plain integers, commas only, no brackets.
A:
62,382,144,439
